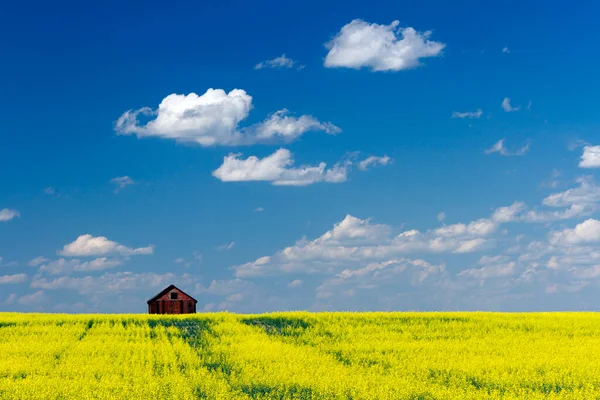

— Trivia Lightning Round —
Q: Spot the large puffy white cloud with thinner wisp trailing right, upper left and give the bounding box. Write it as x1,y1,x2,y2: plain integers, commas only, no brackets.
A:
115,89,341,146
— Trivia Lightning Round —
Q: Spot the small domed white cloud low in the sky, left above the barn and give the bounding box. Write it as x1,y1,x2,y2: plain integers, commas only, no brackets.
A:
58,234,154,257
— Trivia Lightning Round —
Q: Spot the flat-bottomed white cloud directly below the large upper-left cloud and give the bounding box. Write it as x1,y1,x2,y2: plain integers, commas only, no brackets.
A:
212,149,347,186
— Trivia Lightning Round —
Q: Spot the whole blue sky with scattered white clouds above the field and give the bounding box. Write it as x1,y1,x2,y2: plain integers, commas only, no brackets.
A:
0,1,600,313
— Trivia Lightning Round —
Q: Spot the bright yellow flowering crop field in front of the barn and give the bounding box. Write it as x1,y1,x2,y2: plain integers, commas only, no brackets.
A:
0,312,600,400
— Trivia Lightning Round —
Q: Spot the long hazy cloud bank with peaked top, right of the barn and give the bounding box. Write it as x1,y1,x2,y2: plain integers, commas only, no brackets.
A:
233,215,498,278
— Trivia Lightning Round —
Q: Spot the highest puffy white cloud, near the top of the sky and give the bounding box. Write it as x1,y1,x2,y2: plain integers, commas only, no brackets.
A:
325,19,446,71
